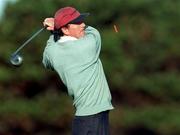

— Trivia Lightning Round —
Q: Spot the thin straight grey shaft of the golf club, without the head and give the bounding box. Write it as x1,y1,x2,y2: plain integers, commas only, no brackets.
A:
13,27,45,55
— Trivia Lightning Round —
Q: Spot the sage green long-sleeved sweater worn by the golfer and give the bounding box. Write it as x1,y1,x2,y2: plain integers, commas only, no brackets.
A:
43,26,113,116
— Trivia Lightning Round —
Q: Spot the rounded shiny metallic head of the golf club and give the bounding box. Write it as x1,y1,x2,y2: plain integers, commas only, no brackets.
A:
10,54,23,66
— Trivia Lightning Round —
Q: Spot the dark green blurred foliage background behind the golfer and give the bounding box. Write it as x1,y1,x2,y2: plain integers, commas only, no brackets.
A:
0,0,180,135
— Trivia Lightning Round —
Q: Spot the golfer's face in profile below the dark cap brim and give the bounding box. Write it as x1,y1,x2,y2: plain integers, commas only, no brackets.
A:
63,22,86,38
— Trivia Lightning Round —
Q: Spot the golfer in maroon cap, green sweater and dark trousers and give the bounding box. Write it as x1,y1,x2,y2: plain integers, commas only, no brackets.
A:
43,7,113,135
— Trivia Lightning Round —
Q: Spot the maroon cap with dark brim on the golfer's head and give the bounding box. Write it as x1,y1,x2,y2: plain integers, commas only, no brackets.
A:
54,7,89,29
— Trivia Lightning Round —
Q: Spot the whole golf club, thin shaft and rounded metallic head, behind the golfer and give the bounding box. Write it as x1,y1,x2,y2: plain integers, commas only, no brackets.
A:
10,27,46,66
